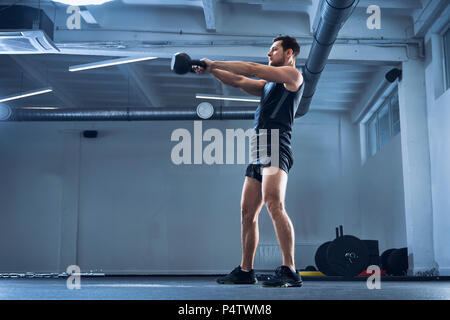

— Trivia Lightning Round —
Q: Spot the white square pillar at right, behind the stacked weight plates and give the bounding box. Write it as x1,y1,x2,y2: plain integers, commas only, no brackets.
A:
398,60,436,275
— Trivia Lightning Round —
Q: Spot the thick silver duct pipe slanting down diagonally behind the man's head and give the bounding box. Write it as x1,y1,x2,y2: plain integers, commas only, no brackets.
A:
295,0,359,118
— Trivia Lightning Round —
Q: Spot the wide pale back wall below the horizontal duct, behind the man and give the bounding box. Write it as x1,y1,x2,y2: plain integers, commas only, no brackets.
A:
0,112,382,273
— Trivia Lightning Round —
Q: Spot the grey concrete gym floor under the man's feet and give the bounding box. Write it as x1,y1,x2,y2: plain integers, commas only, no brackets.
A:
0,276,450,300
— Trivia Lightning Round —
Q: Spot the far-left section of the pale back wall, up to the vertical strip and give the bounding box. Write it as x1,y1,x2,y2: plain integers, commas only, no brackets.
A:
0,127,63,272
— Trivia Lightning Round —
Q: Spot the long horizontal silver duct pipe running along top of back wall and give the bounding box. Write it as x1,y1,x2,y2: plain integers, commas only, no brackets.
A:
0,107,256,121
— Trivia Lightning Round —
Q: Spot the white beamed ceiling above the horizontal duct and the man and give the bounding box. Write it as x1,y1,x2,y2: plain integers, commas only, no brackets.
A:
0,0,439,117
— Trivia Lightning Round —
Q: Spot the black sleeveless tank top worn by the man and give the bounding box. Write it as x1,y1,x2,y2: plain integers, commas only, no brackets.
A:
254,82,304,142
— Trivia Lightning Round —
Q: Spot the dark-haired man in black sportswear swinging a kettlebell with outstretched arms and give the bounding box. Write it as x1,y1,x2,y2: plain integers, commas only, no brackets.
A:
194,36,303,287
